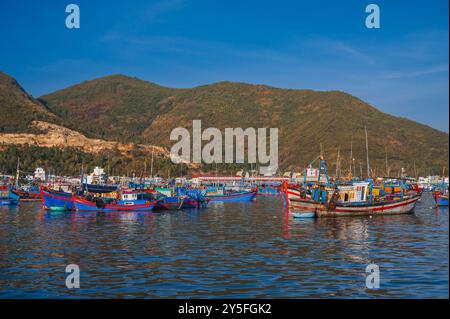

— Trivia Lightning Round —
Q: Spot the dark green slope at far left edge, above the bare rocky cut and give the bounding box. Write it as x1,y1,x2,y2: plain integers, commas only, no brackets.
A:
0,71,59,133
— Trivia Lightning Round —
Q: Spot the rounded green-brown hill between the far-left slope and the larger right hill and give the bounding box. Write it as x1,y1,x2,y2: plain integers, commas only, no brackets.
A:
40,75,178,142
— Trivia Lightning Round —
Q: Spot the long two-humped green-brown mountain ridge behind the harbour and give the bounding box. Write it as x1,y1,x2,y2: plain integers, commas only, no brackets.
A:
40,75,449,176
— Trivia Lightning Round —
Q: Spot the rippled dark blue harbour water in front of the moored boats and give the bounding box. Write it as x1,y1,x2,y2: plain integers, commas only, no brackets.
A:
0,194,449,298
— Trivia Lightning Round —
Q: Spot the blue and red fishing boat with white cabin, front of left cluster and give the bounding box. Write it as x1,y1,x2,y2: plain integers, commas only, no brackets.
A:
72,192,156,212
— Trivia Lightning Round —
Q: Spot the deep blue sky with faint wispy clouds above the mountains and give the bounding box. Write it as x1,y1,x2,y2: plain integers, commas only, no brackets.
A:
0,0,449,132
